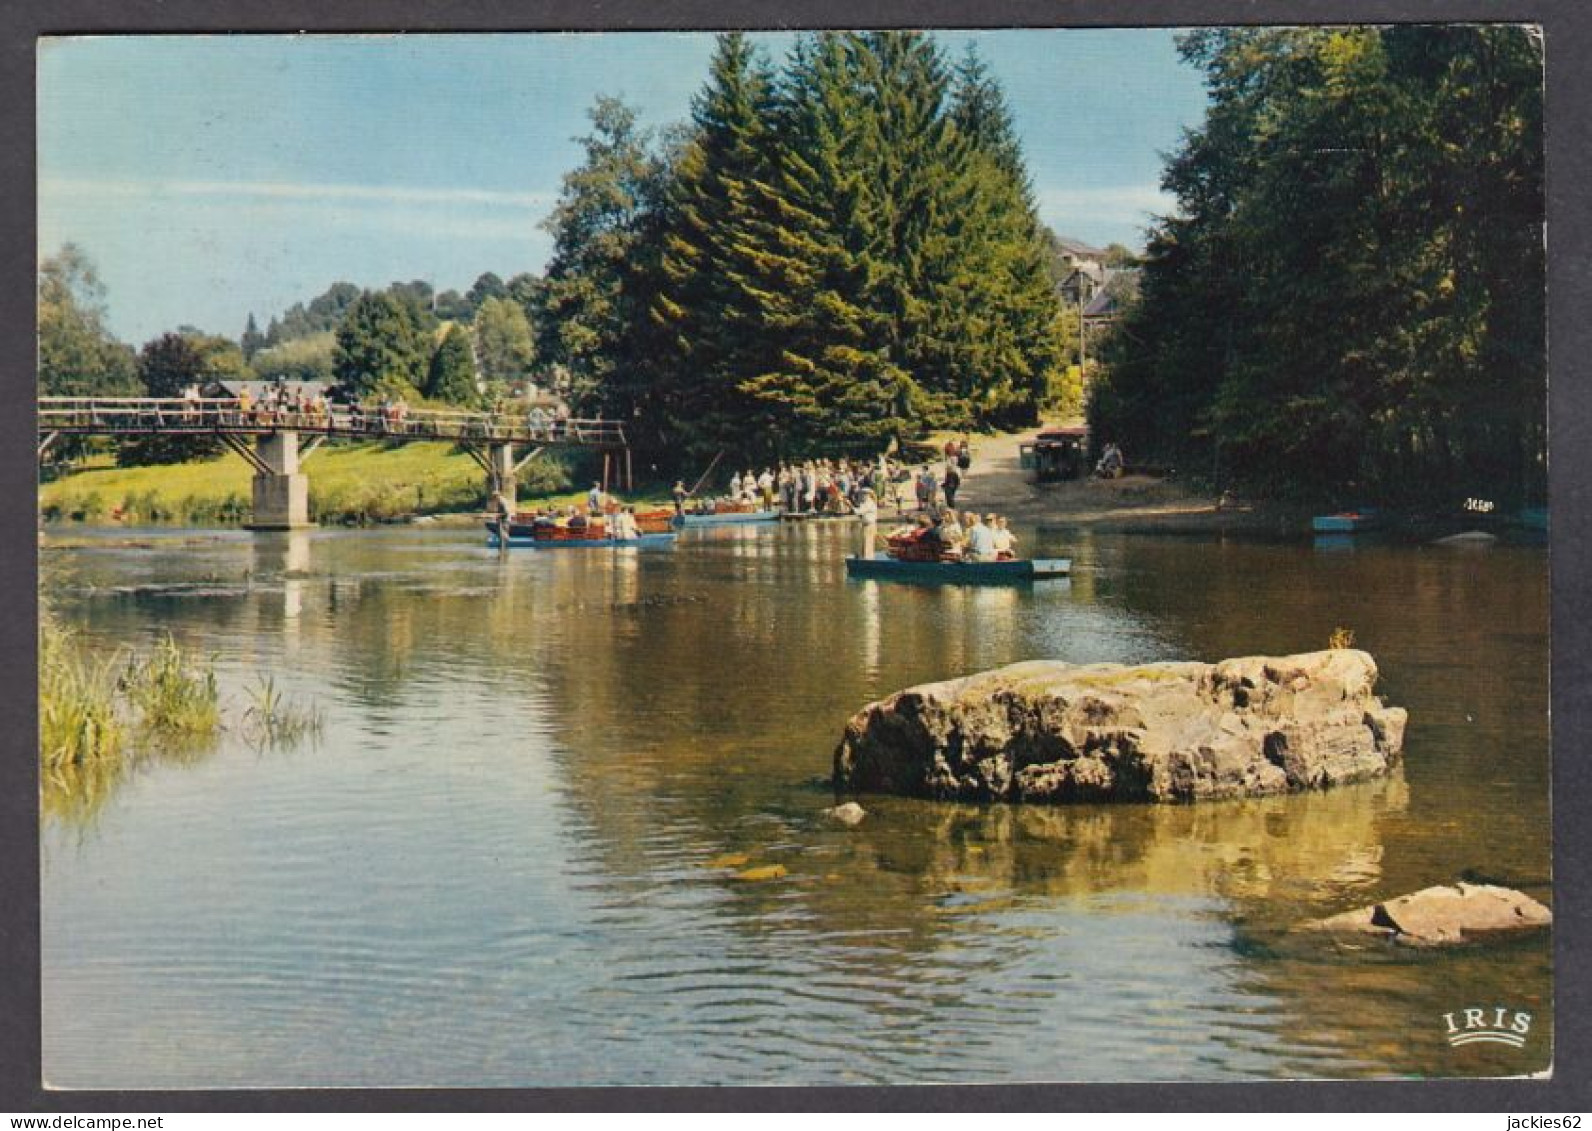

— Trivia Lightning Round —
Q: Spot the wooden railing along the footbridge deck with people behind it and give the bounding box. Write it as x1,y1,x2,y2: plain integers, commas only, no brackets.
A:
38,397,626,448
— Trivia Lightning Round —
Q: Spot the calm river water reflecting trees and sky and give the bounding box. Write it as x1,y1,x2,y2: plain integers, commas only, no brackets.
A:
41,526,1552,1088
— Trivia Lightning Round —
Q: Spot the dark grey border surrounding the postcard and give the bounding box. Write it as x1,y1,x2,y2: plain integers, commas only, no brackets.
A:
0,0,1592,1115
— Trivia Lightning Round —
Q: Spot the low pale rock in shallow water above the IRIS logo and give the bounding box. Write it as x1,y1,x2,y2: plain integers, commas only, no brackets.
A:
1304,884,1554,946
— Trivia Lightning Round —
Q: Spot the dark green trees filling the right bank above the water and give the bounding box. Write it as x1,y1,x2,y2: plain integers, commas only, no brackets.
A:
1089,25,1546,502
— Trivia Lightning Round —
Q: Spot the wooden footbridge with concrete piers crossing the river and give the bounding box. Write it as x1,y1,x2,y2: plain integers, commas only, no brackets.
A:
38,397,630,530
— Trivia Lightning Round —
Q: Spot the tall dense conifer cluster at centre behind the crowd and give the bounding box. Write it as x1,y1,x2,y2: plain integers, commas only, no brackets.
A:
533,32,1063,464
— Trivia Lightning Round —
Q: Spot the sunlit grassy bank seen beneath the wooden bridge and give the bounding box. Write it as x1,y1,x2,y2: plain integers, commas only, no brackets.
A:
38,441,608,524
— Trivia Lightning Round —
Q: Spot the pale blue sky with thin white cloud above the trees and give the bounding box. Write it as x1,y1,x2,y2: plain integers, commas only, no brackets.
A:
38,29,1205,344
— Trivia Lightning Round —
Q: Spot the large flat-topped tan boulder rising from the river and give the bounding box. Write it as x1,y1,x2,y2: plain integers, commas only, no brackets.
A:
834,648,1406,801
